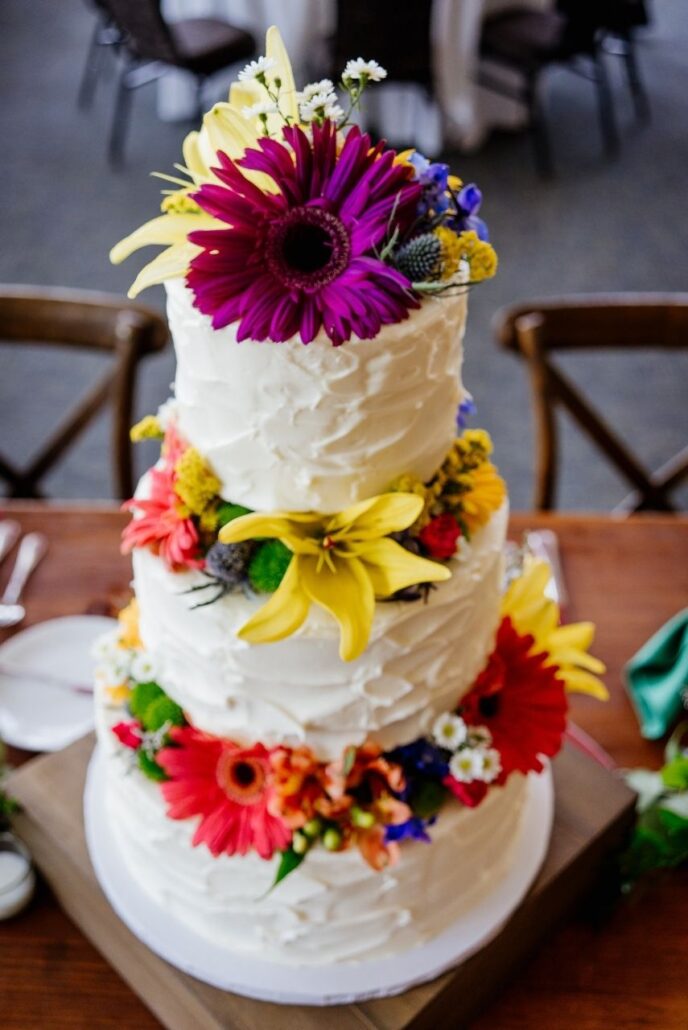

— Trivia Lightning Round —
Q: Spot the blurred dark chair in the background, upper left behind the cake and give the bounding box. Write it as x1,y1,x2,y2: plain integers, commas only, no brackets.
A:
99,0,255,165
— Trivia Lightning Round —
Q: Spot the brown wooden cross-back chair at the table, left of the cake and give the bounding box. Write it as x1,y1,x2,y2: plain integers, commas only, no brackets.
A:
0,285,169,497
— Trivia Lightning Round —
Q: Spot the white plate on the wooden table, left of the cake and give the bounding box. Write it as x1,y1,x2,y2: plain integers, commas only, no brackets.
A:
0,615,116,751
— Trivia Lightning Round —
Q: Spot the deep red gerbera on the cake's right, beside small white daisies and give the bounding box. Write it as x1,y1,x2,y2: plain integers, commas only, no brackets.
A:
460,616,569,783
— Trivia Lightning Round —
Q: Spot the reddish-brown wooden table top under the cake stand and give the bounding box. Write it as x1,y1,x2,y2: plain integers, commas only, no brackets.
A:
0,503,688,1030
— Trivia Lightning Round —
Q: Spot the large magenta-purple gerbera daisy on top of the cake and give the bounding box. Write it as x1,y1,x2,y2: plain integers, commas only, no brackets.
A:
186,122,420,346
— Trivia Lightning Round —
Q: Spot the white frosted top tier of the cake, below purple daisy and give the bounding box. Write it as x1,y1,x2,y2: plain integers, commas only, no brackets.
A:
167,280,466,513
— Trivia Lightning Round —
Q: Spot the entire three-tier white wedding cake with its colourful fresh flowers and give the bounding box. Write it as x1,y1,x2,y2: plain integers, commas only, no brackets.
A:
92,29,604,966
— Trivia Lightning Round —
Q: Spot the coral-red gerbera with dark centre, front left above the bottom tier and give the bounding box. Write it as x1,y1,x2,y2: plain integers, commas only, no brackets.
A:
156,726,291,858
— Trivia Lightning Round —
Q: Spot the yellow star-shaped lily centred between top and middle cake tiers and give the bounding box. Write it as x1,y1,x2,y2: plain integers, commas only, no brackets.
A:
219,493,451,661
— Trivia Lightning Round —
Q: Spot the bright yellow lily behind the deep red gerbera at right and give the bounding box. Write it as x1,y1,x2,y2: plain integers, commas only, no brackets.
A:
502,560,609,701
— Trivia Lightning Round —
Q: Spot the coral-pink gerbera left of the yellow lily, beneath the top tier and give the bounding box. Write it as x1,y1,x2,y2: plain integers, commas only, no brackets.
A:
122,465,204,570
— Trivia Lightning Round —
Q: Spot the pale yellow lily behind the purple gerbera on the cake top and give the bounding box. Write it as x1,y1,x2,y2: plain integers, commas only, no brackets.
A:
110,26,299,298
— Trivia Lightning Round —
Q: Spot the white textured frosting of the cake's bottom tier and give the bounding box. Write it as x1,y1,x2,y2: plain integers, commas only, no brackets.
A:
98,683,526,965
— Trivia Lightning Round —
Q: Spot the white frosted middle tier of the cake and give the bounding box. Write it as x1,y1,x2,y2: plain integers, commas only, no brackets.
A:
134,504,508,760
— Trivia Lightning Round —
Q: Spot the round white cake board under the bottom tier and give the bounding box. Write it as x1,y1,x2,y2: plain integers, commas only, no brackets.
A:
84,748,554,1005
